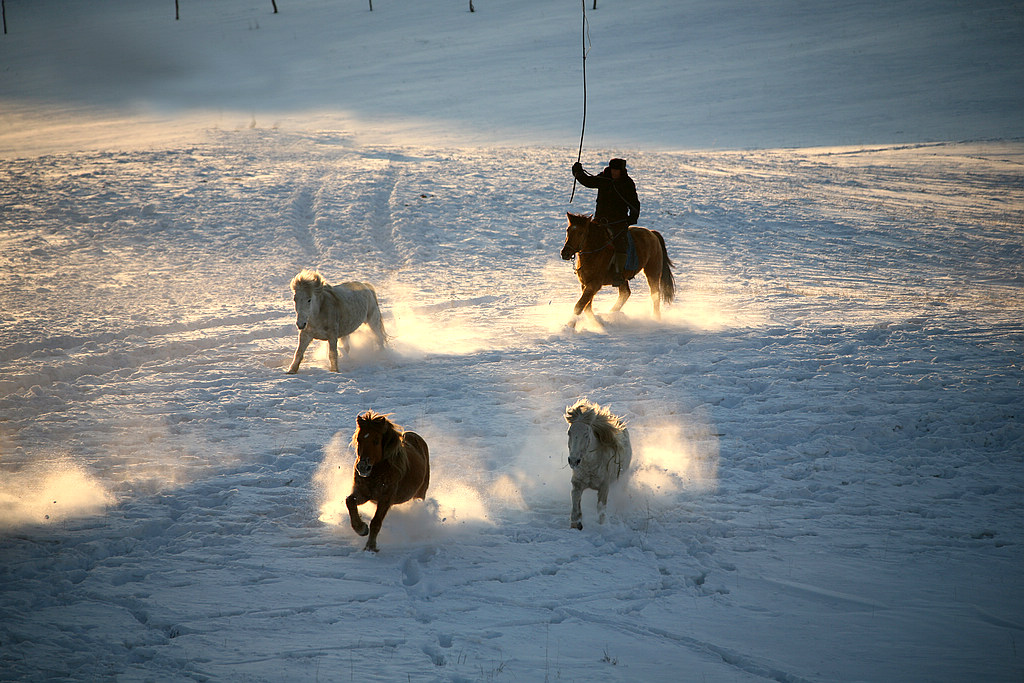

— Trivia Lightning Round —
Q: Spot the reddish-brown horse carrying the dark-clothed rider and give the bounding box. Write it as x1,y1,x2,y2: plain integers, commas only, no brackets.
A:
561,213,676,328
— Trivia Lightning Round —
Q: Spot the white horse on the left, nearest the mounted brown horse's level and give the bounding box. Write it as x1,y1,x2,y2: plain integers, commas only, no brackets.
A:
288,270,387,375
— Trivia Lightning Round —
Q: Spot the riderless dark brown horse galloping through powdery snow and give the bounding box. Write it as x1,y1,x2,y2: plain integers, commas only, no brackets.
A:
345,411,430,552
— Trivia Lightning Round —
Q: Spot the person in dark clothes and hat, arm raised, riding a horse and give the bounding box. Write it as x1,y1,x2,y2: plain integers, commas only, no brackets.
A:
572,159,640,287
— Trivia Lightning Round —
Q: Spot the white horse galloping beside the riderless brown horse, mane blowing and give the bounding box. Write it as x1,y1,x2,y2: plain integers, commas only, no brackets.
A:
565,398,633,529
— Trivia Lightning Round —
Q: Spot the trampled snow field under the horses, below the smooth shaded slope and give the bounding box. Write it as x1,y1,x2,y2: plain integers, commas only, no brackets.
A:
0,0,1024,682
